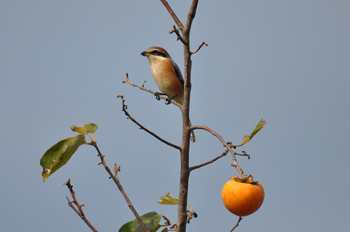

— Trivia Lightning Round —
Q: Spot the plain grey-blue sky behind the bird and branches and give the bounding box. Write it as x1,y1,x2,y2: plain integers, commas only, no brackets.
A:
0,0,350,232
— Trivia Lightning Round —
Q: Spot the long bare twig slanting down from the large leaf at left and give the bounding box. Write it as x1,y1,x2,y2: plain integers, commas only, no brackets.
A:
90,141,149,232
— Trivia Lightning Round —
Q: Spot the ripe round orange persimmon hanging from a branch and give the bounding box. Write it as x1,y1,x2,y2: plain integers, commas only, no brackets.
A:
222,176,265,217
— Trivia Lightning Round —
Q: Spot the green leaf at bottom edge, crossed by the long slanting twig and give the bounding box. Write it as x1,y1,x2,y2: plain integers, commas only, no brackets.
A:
119,212,163,232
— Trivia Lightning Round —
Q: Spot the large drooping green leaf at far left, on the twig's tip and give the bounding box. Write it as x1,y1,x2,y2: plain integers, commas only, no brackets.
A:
40,135,85,181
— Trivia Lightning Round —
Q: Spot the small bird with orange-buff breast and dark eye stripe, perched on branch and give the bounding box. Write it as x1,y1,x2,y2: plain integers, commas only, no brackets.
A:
141,47,196,142
